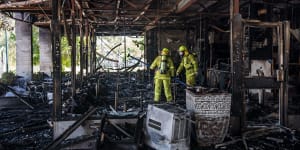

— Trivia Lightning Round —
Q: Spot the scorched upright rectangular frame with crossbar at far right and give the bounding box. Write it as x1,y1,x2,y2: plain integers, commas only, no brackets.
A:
233,18,290,128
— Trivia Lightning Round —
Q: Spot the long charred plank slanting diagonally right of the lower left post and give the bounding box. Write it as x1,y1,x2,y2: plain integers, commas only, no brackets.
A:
45,107,97,150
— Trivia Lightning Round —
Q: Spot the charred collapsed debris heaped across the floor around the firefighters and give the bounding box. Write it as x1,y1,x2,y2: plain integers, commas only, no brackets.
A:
0,72,299,150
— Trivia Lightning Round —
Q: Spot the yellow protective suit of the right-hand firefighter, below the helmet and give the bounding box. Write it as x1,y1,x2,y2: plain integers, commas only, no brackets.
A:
176,53,198,85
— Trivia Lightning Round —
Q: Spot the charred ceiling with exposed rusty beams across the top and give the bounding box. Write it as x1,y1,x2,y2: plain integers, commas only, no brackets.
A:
0,0,300,35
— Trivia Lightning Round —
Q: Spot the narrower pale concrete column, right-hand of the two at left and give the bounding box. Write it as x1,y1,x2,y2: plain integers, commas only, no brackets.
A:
39,28,53,76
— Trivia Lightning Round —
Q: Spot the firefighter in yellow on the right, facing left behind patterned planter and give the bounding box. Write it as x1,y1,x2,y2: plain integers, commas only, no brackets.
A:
176,45,198,86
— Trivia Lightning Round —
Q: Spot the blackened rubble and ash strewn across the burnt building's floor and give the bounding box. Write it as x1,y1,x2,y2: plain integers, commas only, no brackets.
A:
0,72,300,150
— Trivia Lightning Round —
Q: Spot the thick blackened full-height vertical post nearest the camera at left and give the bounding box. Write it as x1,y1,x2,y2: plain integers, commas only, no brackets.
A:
51,0,62,120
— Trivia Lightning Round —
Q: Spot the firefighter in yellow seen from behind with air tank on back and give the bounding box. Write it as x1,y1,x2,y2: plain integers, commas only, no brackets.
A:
150,48,174,102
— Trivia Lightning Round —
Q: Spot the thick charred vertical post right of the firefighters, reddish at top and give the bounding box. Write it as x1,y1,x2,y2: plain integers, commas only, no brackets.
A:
230,0,245,131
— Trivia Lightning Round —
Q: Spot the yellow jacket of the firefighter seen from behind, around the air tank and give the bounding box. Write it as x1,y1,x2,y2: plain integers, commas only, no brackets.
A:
150,56,174,79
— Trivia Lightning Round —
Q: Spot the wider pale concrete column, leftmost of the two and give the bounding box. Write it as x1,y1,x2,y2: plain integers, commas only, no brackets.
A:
15,16,32,80
